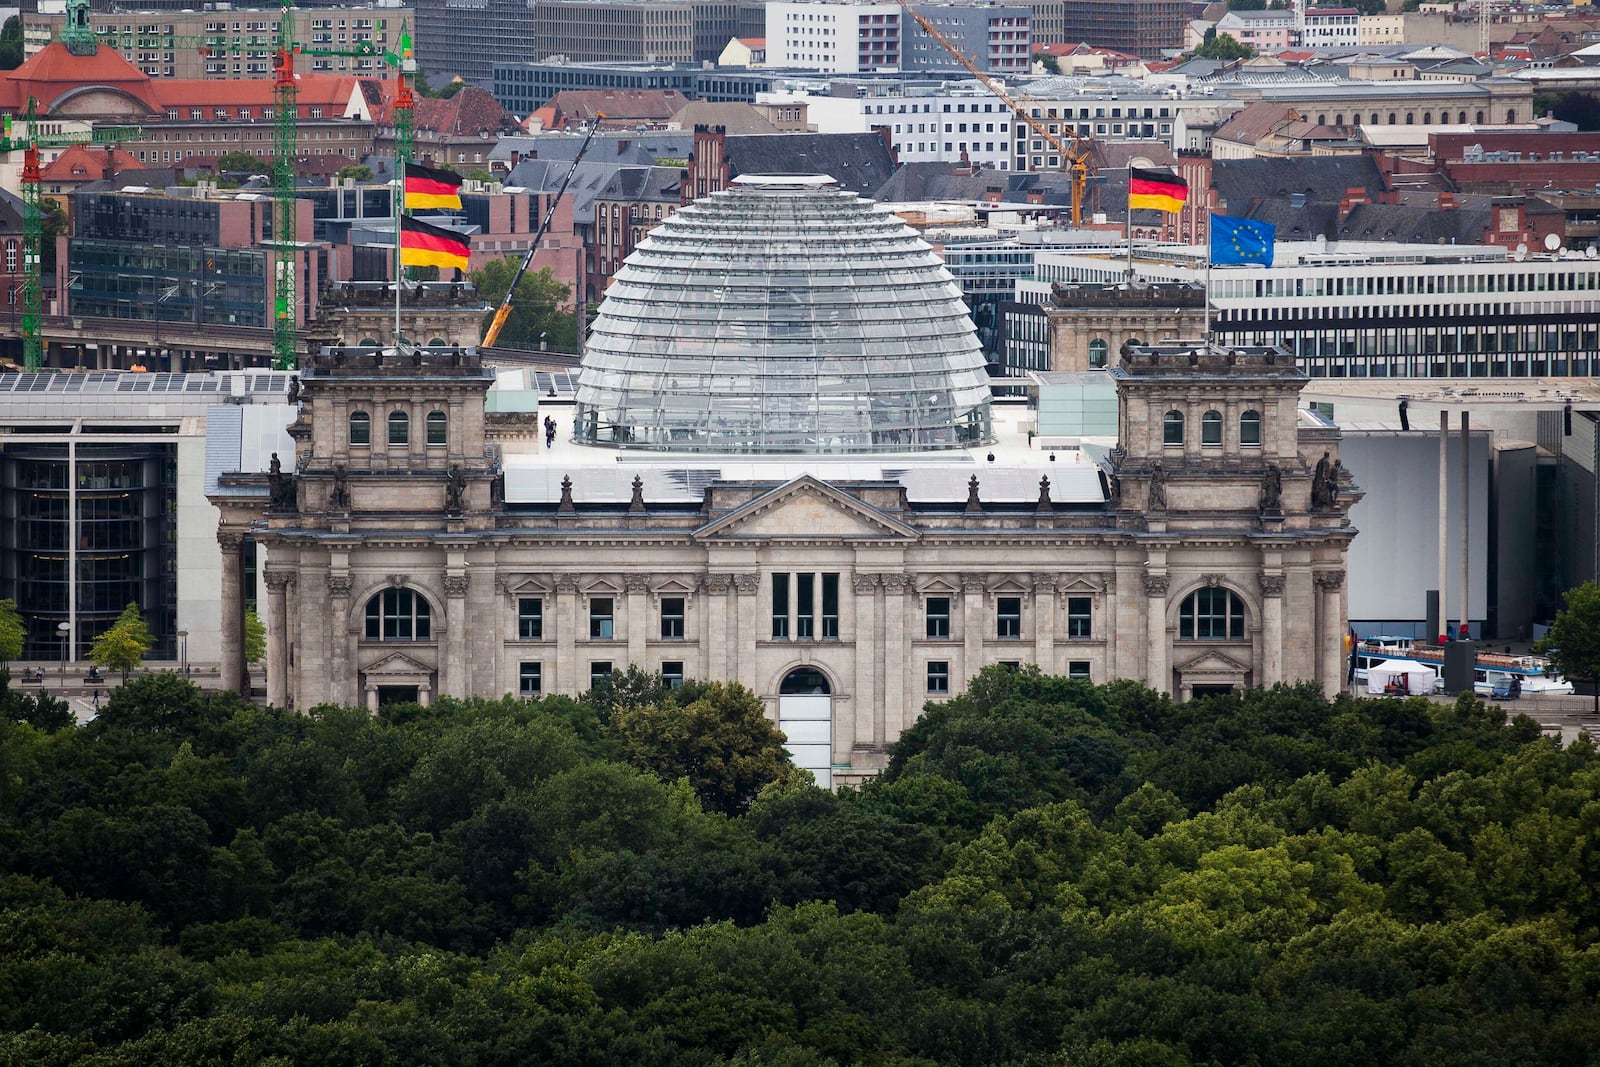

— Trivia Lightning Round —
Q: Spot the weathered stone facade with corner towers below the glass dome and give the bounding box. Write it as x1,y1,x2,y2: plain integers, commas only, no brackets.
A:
213,340,1360,782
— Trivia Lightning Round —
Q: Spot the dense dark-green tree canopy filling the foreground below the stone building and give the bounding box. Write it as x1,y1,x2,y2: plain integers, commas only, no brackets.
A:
0,669,1600,1067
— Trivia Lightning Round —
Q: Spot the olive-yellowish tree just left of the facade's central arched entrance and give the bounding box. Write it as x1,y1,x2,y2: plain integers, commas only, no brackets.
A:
611,681,790,814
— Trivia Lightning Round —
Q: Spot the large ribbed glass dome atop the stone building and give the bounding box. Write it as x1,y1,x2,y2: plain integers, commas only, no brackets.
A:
574,174,990,453
